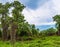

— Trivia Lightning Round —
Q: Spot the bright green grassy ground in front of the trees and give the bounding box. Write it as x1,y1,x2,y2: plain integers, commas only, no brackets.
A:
0,36,60,47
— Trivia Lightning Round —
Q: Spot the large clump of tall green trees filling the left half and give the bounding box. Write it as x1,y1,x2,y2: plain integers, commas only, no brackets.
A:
0,1,39,41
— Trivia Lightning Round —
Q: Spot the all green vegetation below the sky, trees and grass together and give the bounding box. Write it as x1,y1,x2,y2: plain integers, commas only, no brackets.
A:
0,1,60,47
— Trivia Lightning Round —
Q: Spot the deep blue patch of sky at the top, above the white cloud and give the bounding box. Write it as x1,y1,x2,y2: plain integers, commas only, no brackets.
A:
20,0,49,9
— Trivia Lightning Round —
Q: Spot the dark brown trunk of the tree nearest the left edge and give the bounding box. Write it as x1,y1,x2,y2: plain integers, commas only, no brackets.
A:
1,15,8,41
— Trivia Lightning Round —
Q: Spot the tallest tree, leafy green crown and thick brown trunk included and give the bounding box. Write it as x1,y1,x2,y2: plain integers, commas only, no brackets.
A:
11,1,25,43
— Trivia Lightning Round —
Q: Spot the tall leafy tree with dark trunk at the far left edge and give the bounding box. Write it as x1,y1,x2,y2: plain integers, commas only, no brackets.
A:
0,2,10,40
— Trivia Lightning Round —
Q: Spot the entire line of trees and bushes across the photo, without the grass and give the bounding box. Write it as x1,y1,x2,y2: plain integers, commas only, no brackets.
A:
0,1,60,42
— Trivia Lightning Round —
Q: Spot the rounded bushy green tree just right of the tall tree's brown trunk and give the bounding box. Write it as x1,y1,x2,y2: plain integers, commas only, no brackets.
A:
20,22,32,36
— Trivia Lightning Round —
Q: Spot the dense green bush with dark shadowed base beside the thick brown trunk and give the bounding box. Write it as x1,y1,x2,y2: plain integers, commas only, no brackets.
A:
18,23,31,36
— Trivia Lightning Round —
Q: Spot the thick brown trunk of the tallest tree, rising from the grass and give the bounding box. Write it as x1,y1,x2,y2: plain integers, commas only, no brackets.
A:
10,23,17,44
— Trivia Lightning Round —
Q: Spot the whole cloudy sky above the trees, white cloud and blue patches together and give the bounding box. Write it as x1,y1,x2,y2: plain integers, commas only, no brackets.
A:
0,0,60,29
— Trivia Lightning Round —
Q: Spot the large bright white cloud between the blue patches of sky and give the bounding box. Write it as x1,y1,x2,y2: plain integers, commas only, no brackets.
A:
23,0,59,25
